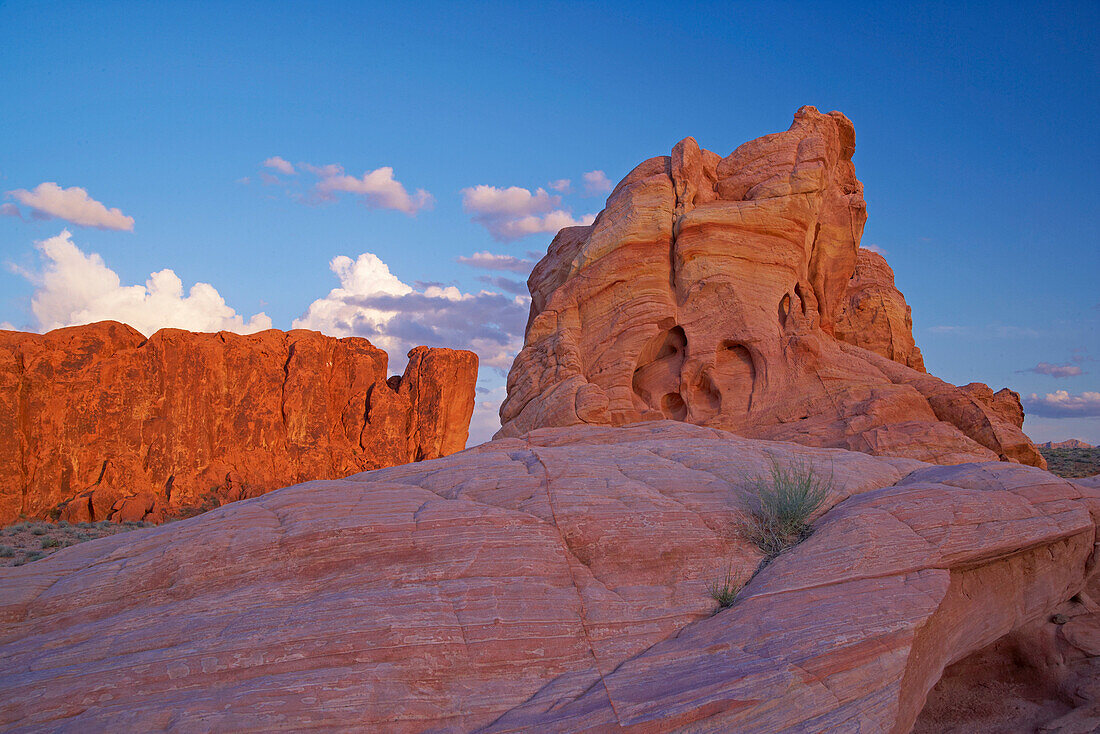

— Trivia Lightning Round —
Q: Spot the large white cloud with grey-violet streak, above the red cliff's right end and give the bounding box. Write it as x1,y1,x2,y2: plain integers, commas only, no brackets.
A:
294,252,530,371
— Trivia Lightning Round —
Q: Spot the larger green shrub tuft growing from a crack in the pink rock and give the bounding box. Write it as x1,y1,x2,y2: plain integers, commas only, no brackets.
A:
745,457,833,558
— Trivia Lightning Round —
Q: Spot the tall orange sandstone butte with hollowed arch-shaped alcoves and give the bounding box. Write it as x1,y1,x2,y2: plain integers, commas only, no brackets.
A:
497,107,1044,467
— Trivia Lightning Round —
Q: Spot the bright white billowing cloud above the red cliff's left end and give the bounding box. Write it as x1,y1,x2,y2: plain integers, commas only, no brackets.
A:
13,230,272,336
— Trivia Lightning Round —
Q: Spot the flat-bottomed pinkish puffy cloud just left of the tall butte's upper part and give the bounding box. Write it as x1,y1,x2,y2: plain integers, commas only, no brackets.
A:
462,184,596,241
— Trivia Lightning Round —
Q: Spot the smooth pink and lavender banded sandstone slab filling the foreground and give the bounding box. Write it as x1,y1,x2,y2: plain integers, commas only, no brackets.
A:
0,421,1100,734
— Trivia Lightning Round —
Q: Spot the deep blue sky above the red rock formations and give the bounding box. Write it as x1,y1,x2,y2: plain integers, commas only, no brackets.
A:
0,2,1100,443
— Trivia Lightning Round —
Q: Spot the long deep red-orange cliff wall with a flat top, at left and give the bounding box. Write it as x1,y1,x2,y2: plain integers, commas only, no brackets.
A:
0,321,477,523
